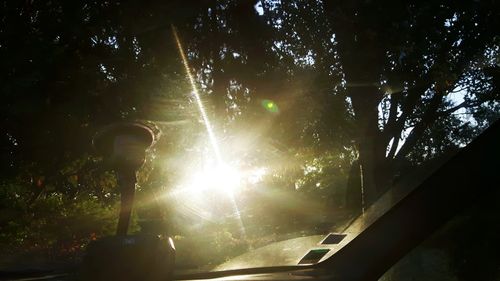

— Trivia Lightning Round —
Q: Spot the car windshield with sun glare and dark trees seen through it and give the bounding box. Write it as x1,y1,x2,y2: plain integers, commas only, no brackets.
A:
0,0,500,272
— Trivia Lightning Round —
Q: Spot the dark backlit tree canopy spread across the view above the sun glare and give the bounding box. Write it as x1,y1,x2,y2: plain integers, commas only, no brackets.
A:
0,0,500,272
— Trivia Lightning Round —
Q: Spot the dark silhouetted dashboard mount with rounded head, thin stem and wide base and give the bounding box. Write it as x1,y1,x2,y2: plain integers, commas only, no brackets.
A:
81,123,175,281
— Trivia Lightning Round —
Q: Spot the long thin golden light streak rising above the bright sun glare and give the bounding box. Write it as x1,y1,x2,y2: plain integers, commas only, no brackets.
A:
172,25,222,165
